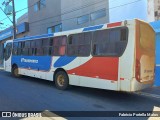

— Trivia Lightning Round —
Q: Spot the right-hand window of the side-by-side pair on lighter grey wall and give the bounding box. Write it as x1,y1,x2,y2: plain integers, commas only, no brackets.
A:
91,9,106,20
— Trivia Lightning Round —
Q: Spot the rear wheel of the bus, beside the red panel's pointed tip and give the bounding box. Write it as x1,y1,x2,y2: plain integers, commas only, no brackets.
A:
55,71,69,90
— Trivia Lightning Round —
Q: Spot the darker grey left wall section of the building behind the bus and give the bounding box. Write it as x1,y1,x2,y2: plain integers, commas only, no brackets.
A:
28,0,61,36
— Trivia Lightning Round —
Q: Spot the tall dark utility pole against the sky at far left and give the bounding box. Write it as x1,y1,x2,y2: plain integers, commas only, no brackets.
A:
12,0,16,39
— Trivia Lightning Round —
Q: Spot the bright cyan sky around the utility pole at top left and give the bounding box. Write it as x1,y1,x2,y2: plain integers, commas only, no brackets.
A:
0,0,28,31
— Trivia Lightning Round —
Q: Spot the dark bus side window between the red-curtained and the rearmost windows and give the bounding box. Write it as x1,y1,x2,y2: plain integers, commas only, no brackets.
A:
67,32,91,56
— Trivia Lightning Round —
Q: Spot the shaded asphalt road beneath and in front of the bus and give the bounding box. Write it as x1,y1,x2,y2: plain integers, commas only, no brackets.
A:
0,71,160,120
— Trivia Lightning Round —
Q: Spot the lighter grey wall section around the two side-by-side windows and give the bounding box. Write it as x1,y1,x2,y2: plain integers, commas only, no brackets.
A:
61,0,109,31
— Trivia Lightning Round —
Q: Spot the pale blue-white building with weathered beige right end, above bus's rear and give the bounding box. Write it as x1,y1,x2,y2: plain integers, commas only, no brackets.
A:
109,0,160,22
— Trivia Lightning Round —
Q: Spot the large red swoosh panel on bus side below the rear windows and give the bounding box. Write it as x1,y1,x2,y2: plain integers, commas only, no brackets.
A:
67,57,119,81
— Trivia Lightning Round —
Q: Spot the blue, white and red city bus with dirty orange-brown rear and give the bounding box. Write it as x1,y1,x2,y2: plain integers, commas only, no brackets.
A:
5,19,155,92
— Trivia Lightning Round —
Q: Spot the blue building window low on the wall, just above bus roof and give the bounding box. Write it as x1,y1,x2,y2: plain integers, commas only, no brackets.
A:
47,24,62,34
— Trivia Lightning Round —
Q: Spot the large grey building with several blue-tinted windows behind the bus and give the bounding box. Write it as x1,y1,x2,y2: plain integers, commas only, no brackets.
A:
28,0,109,35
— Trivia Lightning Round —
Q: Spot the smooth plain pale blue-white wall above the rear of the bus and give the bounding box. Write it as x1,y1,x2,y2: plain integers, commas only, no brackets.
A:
109,0,148,22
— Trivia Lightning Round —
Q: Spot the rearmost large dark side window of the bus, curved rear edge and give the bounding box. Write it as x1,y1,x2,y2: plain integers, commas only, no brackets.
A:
93,27,128,56
